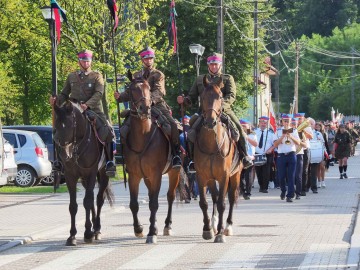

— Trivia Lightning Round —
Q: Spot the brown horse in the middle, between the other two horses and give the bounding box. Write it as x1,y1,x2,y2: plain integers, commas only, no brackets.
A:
124,72,180,243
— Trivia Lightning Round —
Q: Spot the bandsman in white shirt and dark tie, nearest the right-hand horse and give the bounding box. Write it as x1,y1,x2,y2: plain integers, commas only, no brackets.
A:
255,116,274,193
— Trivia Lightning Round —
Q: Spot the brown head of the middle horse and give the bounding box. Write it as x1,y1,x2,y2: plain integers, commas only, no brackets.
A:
128,70,151,119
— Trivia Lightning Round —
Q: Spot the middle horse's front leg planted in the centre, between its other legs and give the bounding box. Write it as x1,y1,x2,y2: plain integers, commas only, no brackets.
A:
144,174,161,244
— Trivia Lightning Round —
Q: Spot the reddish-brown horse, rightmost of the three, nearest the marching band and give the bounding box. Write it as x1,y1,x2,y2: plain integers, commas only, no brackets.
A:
194,76,242,243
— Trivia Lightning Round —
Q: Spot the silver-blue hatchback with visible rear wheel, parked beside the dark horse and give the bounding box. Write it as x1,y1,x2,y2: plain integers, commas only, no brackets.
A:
3,129,51,187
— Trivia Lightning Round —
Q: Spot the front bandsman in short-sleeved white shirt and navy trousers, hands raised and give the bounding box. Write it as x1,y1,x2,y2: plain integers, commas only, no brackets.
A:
271,114,300,202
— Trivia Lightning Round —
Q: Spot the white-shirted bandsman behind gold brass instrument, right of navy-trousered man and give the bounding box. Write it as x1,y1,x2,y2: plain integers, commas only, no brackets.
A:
294,113,313,196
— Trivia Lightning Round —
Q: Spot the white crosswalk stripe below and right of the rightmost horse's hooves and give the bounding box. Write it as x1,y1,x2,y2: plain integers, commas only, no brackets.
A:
209,243,271,269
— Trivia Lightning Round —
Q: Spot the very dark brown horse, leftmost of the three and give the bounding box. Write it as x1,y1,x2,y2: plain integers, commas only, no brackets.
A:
54,100,114,246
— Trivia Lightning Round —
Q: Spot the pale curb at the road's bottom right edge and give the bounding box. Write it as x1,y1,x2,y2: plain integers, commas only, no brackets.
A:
347,195,360,269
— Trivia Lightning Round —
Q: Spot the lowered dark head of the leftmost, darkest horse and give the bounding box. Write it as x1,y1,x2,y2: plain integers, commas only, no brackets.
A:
54,101,85,158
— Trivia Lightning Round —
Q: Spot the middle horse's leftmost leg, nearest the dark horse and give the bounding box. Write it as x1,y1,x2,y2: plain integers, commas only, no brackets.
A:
129,173,144,237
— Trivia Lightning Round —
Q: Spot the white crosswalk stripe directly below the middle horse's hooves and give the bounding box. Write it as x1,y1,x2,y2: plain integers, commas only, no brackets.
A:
118,244,195,269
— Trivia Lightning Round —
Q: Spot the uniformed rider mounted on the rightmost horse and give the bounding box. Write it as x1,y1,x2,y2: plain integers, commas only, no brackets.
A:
177,53,253,171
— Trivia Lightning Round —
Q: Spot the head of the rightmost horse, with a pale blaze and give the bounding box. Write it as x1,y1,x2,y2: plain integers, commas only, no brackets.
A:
200,76,223,129
